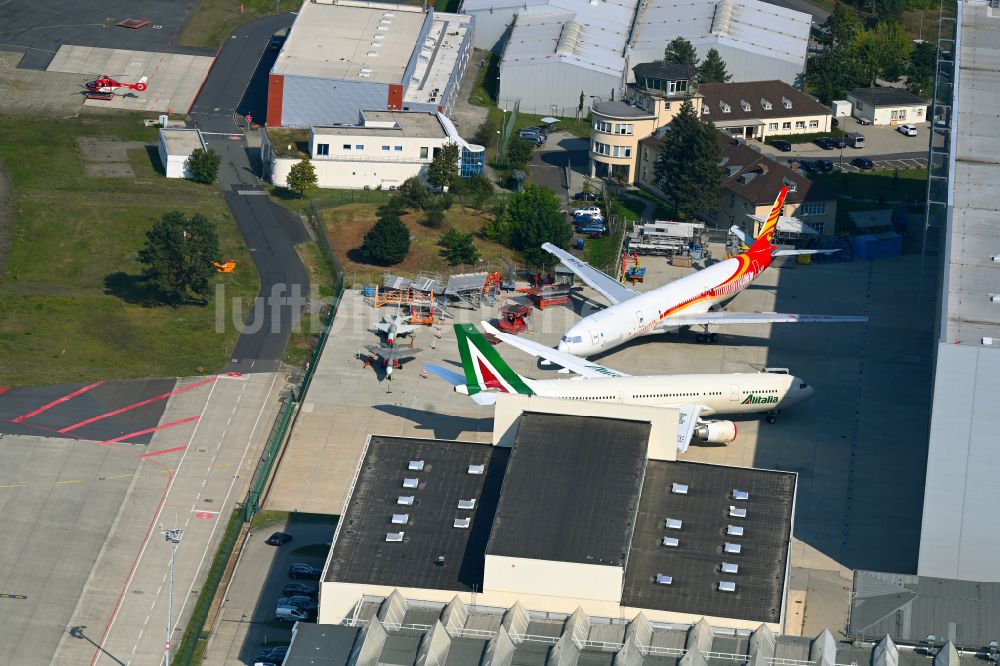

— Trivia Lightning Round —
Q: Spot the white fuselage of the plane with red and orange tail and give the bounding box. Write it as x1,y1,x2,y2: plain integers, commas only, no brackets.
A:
558,250,771,357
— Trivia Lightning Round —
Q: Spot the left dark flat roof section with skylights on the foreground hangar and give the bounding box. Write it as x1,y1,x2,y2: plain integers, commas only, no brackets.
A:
325,435,510,591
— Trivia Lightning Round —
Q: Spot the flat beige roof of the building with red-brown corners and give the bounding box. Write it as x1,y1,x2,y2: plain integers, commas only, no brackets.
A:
271,2,427,84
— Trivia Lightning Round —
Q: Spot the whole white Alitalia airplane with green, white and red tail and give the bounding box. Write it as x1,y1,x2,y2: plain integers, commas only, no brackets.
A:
427,322,815,451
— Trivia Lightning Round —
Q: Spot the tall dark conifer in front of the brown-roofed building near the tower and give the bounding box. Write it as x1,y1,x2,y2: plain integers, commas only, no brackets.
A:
654,101,722,219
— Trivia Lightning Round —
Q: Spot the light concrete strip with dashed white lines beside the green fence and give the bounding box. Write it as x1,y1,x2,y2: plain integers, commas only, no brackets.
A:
52,373,284,664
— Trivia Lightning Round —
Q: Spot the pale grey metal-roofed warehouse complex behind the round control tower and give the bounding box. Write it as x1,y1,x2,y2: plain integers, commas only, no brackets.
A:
462,0,812,116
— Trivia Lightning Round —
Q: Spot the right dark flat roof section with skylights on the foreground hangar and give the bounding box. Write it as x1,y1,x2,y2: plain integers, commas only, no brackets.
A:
622,460,795,623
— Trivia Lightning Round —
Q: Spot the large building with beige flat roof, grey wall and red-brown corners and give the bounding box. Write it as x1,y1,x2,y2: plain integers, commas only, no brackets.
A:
267,0,474,127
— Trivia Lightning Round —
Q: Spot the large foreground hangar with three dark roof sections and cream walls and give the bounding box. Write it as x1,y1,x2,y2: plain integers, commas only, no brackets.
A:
319,396,796,630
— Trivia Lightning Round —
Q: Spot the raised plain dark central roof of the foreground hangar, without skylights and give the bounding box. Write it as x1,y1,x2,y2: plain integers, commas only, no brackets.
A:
486,412,651,566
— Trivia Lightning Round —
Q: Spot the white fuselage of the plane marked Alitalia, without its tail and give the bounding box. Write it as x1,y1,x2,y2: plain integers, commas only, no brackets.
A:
523,372,815,416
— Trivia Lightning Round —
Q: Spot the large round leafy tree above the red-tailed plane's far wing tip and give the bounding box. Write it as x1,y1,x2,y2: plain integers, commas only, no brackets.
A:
506,185,573,267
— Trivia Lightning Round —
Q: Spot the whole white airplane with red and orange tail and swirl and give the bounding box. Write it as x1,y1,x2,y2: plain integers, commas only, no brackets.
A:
542,187,868,357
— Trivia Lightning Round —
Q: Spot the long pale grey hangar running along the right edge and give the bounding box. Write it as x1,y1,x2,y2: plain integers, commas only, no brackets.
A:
917,1,1000,580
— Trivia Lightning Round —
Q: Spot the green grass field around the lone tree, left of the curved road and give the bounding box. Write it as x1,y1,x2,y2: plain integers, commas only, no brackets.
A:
0,114,258,385
